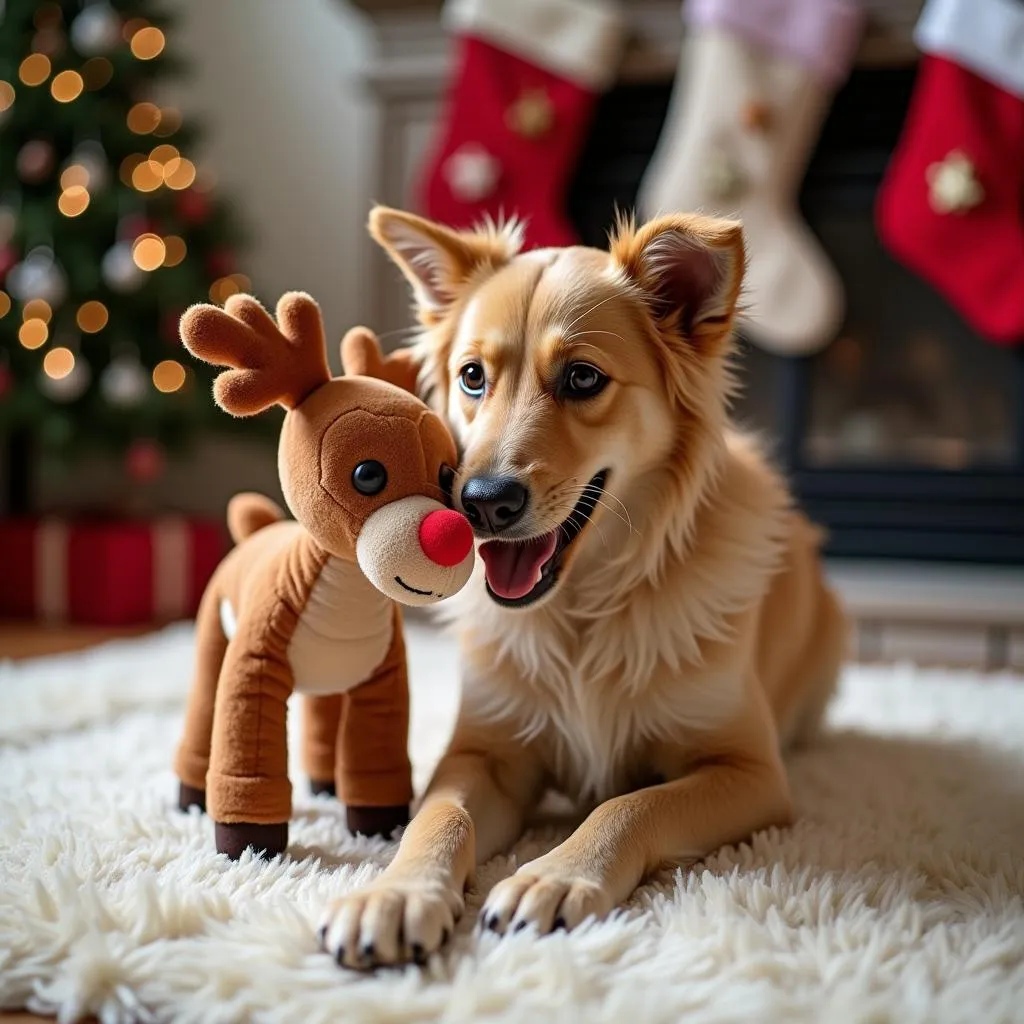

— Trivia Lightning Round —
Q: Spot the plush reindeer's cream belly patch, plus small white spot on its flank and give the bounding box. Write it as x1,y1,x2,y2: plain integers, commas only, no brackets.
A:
220,558,394,693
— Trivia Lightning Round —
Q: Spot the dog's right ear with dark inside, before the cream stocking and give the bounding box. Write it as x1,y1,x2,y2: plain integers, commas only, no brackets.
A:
610,214,744,347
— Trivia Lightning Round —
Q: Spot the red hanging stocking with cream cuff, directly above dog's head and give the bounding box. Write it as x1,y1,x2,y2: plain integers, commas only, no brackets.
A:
421,0,624,248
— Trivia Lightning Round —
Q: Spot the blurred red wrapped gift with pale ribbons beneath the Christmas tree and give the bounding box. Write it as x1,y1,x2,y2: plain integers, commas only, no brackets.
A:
0,516,228,626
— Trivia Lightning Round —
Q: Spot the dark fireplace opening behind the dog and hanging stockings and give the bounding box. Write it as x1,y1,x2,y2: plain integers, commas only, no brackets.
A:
568,67,1024,564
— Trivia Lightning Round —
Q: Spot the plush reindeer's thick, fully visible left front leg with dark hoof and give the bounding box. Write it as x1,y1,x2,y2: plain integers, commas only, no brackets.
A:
207,620,293,858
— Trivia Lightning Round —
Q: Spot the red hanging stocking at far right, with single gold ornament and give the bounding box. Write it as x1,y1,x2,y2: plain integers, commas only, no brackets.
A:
878,0,1024,344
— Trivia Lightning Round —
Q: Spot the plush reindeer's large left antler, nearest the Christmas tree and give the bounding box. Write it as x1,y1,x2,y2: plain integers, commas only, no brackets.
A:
180,292,331,416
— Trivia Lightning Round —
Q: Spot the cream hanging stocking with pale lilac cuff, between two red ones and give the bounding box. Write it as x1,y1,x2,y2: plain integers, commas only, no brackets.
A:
640,0,862,354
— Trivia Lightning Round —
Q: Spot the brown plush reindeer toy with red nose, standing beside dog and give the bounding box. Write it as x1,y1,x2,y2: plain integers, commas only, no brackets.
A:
175,293,473,857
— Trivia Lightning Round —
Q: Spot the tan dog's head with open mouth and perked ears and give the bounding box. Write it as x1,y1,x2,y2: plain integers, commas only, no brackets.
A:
370,208,743,607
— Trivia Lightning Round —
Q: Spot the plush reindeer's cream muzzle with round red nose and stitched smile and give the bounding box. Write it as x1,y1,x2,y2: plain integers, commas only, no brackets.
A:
355,495,473,604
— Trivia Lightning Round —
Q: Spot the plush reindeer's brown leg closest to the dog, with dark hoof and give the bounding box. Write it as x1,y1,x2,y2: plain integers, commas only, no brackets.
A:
336,611,413,836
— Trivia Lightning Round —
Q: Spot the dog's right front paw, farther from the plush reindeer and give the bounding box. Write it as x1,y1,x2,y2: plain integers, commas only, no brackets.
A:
480,856,614,935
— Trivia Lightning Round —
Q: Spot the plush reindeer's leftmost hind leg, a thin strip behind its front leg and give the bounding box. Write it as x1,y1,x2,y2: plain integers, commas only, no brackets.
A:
174,587,227,810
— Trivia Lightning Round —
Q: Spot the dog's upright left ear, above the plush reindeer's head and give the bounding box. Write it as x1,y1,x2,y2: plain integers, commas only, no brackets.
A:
370,206,522,323
